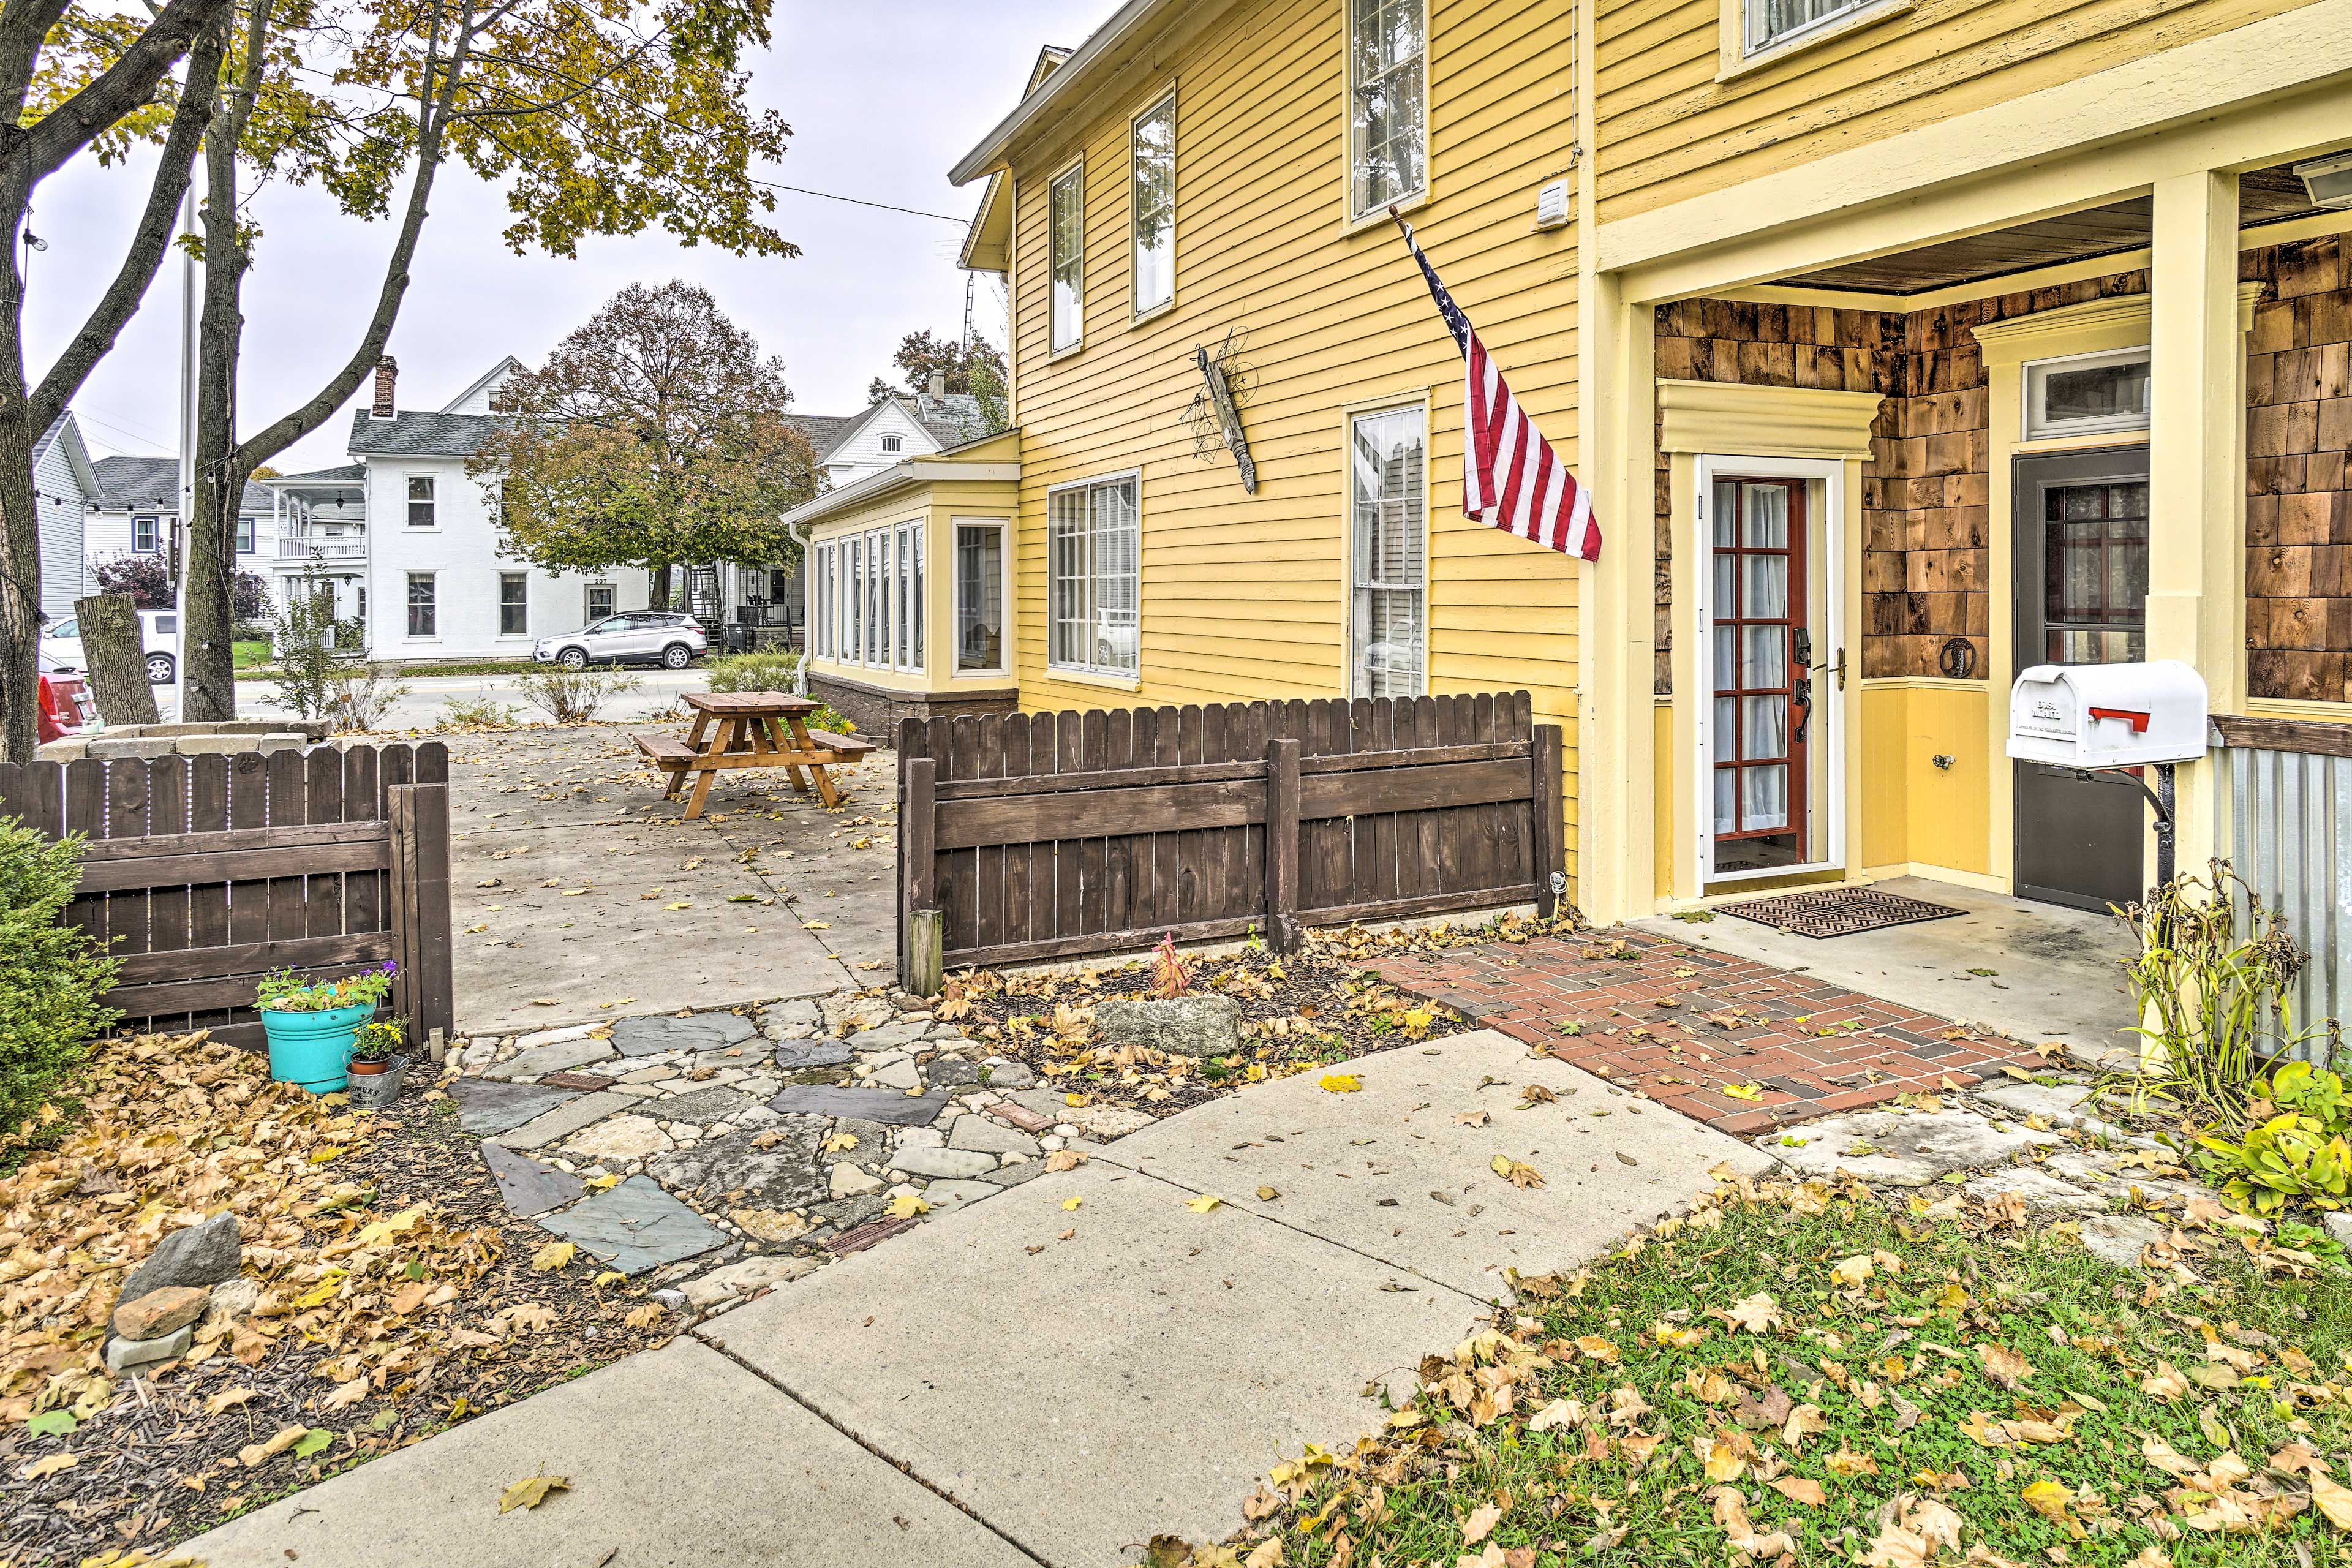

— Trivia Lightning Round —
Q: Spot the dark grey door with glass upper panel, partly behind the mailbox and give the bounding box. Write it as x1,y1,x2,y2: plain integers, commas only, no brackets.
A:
2013,447,2147,910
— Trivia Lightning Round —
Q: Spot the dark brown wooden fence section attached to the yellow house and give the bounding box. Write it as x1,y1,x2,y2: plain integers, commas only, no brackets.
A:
899,691,1564,982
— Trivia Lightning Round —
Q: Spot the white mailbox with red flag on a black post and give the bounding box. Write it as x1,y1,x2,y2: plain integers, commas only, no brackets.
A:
2008,658,2206,769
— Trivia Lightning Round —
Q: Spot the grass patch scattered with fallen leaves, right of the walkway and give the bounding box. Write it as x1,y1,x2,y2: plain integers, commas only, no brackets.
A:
1171,1180,2352,1568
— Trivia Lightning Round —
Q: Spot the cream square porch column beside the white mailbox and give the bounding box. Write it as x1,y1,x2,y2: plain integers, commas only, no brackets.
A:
2147,169,2246,875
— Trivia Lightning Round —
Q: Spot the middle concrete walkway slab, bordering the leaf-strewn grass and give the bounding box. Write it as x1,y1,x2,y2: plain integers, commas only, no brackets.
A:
706,1161,1479,1568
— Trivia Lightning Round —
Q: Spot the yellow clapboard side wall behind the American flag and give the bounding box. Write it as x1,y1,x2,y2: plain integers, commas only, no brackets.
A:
1014,0,1609,870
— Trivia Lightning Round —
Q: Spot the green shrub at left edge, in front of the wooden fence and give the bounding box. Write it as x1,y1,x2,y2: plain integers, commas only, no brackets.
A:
0,818,120,1156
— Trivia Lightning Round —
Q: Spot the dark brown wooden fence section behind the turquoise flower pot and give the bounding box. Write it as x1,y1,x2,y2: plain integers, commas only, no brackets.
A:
0,741,454,1046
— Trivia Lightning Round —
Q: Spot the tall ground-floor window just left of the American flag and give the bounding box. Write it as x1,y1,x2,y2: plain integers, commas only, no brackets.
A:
1348,407,1428,696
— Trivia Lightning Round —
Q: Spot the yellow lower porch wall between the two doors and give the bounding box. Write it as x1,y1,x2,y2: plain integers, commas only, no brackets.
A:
1858,679,2008,877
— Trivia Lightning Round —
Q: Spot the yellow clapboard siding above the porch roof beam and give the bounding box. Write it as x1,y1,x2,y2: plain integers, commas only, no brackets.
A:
1595,0,2302,224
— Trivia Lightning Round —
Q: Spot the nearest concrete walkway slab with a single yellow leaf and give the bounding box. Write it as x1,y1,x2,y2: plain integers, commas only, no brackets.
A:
174,1340,1033,1568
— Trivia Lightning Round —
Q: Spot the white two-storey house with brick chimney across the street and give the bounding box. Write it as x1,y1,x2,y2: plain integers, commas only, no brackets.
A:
268,355,647,661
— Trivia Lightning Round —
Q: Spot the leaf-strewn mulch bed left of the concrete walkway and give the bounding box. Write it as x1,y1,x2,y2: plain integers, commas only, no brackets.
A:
0,1035,673,1568
